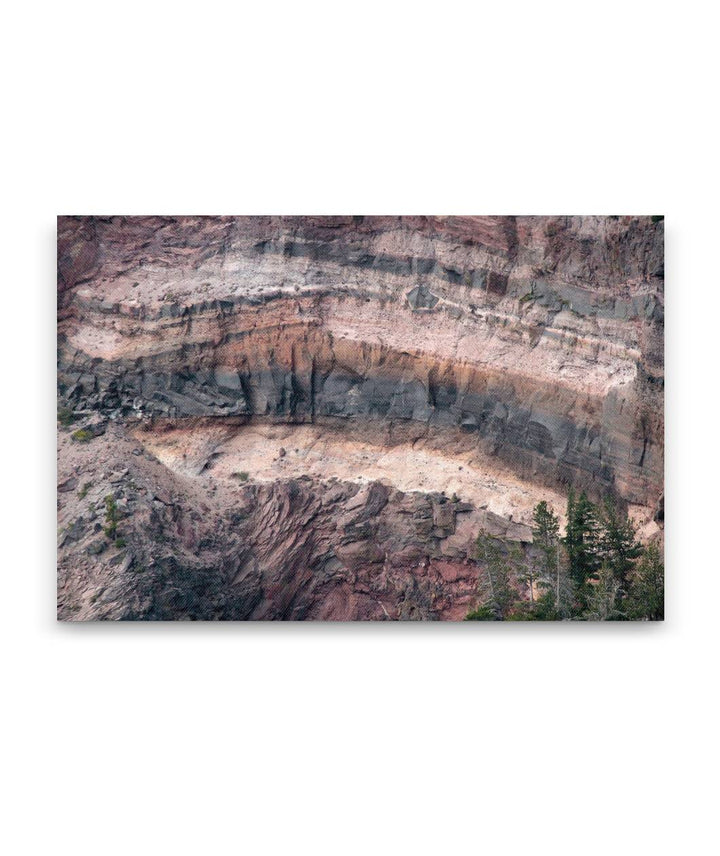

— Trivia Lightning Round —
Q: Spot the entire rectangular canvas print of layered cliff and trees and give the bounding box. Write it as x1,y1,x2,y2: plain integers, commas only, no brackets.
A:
58,216,664,621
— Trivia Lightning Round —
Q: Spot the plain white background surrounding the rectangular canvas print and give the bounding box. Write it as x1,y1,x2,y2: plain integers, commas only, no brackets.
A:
0,0,720,856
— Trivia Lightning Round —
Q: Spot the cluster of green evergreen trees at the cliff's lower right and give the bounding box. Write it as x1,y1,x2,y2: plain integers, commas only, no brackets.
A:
466,490,665,621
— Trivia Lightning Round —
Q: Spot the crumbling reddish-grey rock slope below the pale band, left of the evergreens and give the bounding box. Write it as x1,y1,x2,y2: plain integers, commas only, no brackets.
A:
58,426,500,620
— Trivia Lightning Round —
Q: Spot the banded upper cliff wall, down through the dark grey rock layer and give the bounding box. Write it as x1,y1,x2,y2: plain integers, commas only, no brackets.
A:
58,217,663,507
